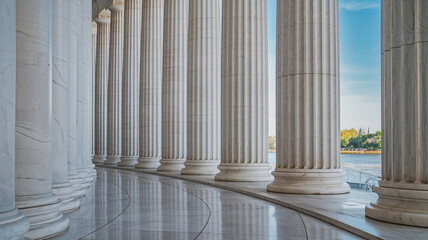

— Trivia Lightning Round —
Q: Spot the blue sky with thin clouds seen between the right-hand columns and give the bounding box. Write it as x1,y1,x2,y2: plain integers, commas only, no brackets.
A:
268,0,381,136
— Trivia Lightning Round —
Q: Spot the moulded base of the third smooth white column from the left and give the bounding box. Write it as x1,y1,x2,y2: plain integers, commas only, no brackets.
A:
52,182,80,213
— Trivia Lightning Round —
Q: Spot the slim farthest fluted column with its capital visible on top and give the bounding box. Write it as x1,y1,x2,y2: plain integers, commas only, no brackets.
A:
94,10,110,164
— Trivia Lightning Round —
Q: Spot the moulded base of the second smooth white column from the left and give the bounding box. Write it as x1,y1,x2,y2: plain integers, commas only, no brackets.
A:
16,193,69,239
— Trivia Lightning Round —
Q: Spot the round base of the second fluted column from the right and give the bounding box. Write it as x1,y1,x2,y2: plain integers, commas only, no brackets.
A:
267,168,350,195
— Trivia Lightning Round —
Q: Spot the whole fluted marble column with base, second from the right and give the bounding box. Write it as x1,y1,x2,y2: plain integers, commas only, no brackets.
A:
268,0,349,194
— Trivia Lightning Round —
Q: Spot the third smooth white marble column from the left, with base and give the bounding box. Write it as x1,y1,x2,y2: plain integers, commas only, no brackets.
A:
51,0,80,212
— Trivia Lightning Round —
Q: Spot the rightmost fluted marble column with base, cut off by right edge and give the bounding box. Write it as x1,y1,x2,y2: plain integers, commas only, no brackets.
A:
366,0,428,227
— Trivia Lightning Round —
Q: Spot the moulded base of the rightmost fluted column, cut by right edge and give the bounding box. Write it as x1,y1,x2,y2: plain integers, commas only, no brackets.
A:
366,181,428,227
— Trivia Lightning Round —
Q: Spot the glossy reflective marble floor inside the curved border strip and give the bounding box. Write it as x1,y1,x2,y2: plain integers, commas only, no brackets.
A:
56,169,359,239
